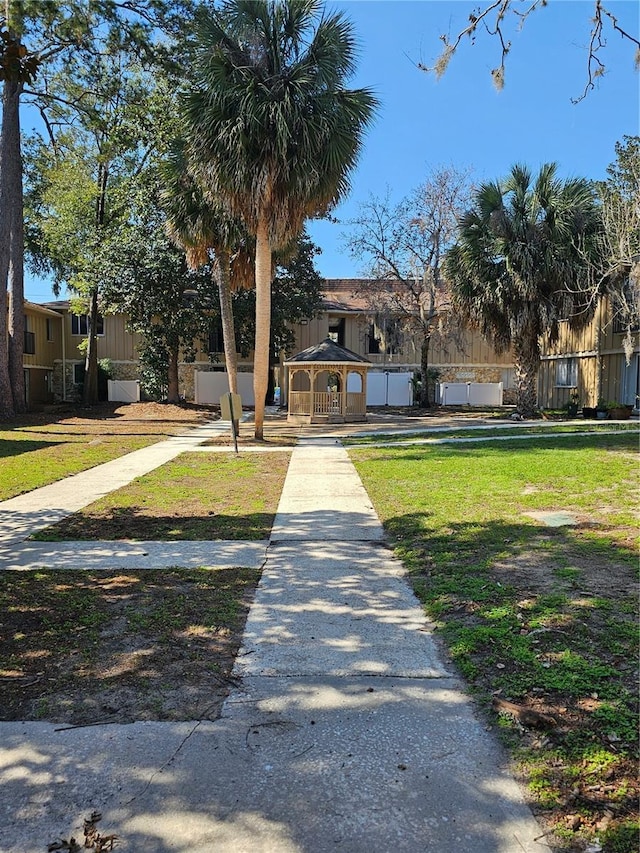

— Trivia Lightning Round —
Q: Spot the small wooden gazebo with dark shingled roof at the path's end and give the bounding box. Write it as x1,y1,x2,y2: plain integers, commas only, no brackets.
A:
284,338,371,424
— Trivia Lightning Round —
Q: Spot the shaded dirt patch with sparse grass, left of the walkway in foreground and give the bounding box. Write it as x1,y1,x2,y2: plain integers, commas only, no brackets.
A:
0,568,259,725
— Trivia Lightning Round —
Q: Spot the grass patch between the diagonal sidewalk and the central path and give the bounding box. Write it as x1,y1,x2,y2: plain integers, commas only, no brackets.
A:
33,451,290,541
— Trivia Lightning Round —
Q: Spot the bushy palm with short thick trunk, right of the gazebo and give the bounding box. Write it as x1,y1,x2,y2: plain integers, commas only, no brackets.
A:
445,163,601,417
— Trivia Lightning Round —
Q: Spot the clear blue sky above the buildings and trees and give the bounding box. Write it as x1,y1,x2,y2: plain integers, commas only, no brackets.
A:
26,0,640,301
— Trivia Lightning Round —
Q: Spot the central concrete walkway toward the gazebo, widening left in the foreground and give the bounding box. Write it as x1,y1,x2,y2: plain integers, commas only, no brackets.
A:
0,439,549,853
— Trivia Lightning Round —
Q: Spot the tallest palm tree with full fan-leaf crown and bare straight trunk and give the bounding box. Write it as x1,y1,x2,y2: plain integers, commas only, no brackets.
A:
185,0,377,439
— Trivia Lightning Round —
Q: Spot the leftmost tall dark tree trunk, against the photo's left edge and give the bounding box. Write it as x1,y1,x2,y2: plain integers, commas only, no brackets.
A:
0,80,21,420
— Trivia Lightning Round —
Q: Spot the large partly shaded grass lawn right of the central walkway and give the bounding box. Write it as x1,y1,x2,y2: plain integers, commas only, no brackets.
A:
350,432,638,853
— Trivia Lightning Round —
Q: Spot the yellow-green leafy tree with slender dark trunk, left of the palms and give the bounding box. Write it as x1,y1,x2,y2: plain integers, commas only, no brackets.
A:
24,45,179,404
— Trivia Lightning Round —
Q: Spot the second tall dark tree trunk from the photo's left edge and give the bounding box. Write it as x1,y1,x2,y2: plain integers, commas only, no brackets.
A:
8,84,27,414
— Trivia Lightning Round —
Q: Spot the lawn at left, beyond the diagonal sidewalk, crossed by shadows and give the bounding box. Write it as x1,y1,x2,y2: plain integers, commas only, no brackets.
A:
0,403,211,500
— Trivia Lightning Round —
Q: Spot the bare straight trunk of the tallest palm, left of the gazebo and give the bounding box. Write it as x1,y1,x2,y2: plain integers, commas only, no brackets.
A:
253,216,272,440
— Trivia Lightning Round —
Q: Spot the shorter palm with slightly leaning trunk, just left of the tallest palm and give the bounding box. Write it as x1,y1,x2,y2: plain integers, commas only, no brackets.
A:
162,141,253,402
